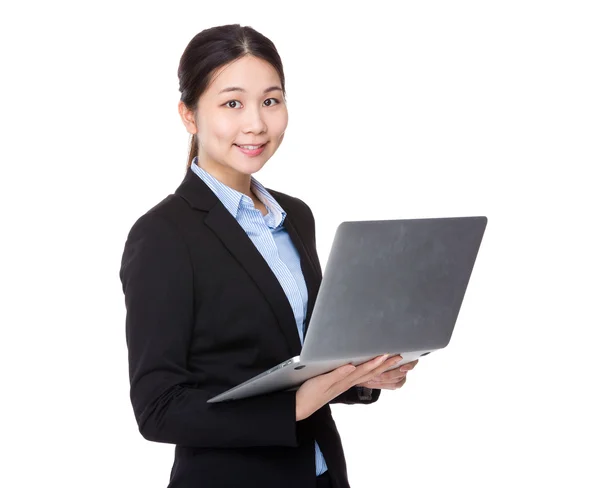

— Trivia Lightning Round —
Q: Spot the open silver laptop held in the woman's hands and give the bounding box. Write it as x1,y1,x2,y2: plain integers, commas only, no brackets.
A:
208,217,487,403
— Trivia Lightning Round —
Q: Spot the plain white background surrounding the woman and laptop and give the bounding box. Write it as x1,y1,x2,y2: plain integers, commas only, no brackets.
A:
0,0,600,488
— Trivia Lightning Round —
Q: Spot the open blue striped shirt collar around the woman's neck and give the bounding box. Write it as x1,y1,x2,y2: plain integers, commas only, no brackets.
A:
190,157,287,228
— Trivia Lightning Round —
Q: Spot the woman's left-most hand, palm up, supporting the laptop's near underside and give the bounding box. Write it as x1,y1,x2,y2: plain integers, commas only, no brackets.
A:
296,354,402,420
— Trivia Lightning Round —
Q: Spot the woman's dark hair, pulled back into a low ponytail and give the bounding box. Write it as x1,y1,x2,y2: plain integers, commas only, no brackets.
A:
177,24,285,168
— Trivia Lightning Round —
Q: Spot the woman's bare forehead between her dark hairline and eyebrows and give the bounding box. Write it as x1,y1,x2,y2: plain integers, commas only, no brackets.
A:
207,56,281,96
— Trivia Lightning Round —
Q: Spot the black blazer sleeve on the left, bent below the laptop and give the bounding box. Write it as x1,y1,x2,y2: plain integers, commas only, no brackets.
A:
119,213,299,448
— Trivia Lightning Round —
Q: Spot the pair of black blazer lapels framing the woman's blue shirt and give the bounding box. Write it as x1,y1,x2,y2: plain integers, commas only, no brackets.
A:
175,169,316,356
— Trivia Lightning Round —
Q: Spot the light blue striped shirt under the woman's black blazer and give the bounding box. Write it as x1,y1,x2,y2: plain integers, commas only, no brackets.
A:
191,158,327,475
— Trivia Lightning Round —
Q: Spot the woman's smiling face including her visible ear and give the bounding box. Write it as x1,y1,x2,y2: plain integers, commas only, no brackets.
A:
179,55,288,193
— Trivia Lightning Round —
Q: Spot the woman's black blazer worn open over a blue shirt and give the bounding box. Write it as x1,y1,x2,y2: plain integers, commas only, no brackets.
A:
119,169,381,488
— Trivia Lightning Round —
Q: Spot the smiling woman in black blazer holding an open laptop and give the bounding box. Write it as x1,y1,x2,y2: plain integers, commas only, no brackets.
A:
120,24,414,488
